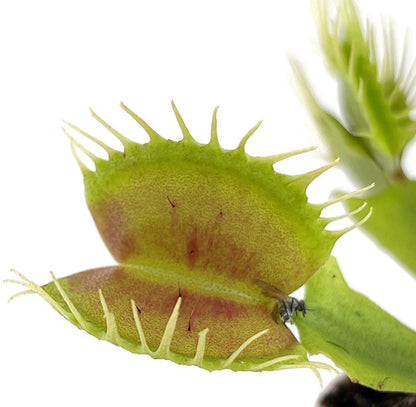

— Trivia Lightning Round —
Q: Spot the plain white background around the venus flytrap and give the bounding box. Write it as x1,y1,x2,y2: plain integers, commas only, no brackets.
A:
0,0,416,407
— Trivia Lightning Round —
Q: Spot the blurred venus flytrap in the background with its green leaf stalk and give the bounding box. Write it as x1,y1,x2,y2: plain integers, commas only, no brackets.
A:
292,0,416,274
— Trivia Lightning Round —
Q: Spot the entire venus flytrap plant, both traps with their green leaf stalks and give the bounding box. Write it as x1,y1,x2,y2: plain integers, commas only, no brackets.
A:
3,0,416,402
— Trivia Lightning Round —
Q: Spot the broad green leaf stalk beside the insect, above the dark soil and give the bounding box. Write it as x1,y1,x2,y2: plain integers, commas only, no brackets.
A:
295,257,416,392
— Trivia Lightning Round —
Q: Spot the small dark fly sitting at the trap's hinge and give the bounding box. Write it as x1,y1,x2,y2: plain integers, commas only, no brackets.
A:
255,280,306,323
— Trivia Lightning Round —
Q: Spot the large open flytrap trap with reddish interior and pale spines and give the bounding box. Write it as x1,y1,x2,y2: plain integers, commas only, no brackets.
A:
10,104,371,372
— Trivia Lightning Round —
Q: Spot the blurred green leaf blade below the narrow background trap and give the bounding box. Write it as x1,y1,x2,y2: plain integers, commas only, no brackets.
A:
346,180,416,277
